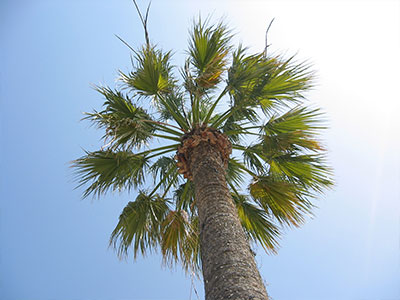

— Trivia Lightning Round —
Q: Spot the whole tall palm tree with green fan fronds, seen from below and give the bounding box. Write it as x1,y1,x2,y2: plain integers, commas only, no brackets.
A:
73,11,332,300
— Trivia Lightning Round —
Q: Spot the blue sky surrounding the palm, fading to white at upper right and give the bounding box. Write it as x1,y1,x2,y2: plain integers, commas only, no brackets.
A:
0,0,400,300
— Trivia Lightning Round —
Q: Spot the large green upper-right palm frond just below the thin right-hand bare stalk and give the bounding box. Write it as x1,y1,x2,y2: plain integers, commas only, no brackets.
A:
227,46,313,122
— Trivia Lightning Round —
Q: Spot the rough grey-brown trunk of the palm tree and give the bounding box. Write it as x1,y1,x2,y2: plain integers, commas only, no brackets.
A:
190,143,268,300
